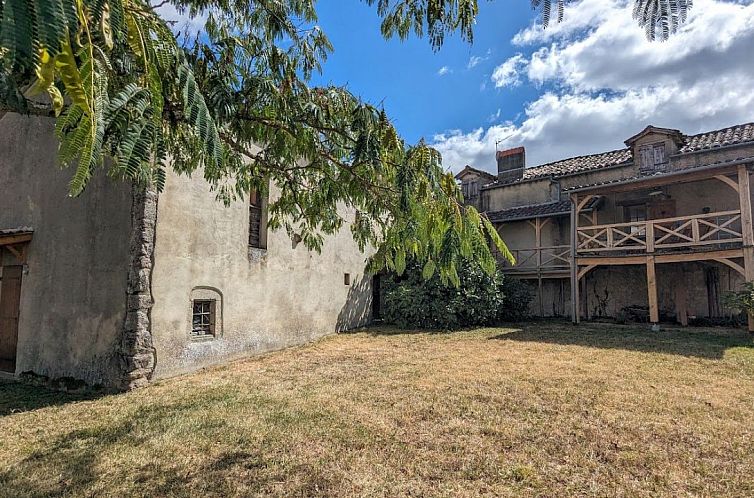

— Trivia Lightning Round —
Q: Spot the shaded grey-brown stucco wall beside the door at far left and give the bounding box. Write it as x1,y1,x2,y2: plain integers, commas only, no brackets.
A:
0,114,131,384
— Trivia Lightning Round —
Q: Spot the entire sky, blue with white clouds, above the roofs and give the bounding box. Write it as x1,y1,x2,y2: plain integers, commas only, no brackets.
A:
161,0,754,172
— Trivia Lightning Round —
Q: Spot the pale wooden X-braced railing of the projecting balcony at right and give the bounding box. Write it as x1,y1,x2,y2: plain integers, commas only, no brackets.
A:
577,211,743,253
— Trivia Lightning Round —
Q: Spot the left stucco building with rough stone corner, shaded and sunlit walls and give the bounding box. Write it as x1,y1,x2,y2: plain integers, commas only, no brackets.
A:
0,114,371,388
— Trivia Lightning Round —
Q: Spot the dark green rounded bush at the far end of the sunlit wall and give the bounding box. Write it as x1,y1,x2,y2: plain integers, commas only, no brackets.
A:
383,264,531,330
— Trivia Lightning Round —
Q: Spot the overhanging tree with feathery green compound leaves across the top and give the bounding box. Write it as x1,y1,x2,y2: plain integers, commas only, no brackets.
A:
0,0,690,284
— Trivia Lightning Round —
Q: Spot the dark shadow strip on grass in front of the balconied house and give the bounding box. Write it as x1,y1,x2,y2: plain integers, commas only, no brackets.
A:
490,324,754,359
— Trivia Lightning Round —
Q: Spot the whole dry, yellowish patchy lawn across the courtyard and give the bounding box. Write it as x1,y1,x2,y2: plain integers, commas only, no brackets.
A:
0,324,754,496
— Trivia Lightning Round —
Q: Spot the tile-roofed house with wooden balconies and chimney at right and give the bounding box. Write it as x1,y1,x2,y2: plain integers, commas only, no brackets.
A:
458,124,754,324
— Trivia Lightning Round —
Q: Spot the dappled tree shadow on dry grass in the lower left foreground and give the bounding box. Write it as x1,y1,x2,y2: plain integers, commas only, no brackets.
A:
0,389,346,497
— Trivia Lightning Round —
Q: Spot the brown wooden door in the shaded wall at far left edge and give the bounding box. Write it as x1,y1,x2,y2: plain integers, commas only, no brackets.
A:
0,266,23,373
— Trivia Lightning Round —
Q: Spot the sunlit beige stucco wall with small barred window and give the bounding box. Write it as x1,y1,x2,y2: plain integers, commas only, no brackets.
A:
152,169,371,377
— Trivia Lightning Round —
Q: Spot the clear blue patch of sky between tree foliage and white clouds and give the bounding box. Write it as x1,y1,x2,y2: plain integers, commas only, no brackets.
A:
308,0,536,146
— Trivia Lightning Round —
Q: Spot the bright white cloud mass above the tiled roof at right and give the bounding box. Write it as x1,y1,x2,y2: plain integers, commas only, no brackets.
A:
434,0,754,171
